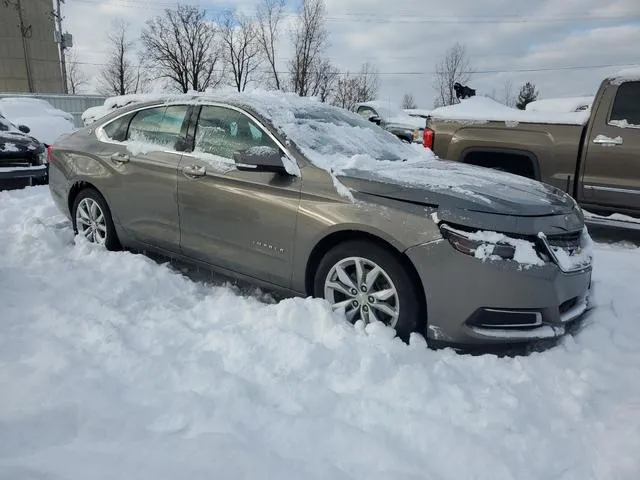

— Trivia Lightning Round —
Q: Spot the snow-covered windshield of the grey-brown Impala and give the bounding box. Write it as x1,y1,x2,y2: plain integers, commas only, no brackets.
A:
279,104,415,161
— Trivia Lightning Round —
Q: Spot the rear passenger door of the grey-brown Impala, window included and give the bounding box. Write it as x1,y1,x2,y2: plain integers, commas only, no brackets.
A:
96,105,191,253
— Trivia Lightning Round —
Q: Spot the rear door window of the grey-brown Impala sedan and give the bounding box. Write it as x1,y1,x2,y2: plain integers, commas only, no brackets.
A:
126,105,189,150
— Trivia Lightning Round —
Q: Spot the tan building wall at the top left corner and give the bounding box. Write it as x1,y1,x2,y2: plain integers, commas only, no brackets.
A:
0,0,63,93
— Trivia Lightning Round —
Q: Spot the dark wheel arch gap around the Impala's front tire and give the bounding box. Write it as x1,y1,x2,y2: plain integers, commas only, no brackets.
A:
305,230,427,334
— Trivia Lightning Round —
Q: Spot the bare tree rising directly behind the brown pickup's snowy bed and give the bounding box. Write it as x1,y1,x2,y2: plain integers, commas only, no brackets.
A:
433,43,471,107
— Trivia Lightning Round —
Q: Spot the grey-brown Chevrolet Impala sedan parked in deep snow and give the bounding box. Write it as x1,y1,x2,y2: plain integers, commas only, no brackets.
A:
50,93,591,345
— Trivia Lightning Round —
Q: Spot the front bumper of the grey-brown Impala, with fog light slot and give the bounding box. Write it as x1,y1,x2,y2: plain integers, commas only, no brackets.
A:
406,240,591,345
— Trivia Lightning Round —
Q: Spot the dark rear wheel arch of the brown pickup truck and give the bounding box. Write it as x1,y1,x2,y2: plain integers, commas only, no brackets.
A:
460,148,541,180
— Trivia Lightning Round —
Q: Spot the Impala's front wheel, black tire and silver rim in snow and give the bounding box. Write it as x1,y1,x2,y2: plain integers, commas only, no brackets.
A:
314,240,424,341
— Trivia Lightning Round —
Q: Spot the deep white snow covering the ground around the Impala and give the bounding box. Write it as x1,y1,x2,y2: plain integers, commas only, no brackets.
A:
0,187,640,480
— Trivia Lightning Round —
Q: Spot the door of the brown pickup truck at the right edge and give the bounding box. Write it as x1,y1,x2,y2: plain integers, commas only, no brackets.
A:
582,82,640,211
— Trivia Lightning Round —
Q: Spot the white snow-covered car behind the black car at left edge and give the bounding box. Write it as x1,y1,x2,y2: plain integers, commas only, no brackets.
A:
0,97,75,145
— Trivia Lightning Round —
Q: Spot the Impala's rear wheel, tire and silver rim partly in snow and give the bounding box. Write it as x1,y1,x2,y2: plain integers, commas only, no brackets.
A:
71,188,120,250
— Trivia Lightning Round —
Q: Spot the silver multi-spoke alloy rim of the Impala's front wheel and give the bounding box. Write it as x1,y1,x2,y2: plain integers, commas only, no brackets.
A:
324,257,400,328
